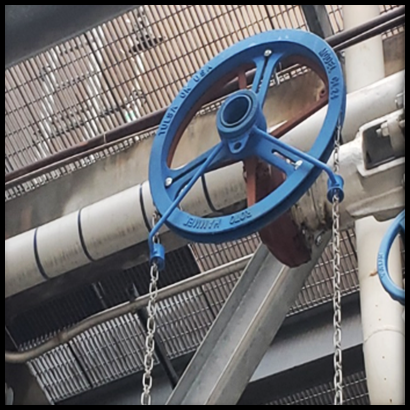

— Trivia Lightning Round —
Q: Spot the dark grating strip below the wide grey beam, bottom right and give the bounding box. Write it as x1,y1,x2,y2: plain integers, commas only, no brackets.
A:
267,371,370,406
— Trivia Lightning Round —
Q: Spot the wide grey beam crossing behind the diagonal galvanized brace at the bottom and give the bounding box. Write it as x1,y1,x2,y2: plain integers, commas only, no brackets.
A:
58,292,364,406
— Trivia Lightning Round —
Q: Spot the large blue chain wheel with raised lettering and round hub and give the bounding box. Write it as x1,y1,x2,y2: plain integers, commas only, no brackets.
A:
149,30,346,243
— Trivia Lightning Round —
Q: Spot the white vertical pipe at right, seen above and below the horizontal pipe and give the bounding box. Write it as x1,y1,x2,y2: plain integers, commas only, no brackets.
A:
343,5,404,405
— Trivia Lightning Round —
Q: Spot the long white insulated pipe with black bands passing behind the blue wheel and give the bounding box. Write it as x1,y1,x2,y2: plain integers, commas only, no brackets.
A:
5,72,404,297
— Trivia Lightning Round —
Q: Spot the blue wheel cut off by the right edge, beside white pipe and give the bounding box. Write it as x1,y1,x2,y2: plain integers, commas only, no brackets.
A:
377,211,405,306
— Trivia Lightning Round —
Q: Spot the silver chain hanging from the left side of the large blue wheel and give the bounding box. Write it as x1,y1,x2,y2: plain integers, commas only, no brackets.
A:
141,212,159,406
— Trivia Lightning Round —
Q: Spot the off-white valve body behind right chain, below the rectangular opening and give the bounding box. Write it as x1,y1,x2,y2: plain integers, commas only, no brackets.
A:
291,133,405,232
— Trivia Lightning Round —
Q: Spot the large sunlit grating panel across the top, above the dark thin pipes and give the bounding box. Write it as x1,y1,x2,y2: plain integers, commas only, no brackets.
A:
5,5,397,178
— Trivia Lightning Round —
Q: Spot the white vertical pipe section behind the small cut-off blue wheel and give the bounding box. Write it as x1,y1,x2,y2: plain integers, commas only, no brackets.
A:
356,217,405,405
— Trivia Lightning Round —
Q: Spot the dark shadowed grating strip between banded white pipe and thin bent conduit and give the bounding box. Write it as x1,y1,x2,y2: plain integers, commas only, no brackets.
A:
6,247,199,350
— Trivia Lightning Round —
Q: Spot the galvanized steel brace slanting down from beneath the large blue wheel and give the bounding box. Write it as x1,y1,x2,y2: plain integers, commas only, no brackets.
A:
167,233,330,405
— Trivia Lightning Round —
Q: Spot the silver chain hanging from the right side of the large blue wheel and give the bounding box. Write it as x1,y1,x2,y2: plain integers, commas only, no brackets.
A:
332,124,343,406
